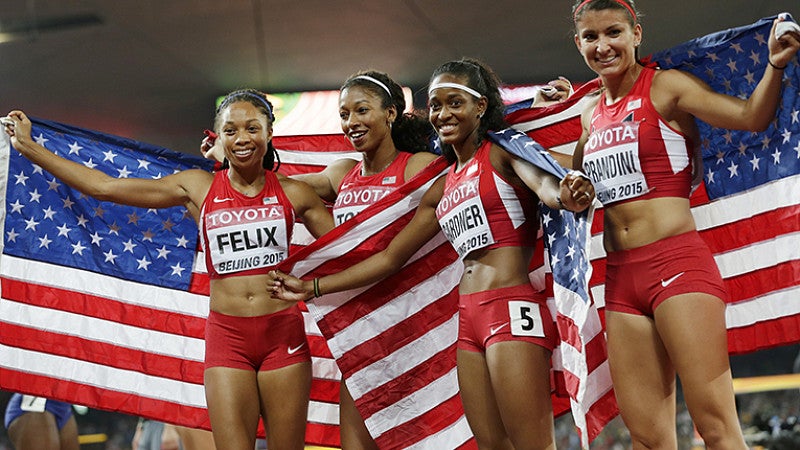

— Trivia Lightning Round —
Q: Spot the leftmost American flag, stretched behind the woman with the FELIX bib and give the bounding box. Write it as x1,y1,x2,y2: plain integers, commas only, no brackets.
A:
0,120,339,445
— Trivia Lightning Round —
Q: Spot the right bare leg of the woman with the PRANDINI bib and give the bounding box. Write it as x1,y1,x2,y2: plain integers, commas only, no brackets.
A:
655,293,747,449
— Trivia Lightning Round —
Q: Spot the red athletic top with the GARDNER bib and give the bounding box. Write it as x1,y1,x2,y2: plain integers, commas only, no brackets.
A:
436,140,539,259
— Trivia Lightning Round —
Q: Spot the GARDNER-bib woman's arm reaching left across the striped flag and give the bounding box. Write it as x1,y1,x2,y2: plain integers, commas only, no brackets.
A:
272,177,444,301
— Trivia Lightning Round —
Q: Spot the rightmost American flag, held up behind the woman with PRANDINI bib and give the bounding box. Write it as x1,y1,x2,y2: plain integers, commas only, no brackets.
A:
652,17,800,354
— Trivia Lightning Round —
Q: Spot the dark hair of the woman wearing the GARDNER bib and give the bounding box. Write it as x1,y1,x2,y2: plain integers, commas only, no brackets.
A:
429,58,508,162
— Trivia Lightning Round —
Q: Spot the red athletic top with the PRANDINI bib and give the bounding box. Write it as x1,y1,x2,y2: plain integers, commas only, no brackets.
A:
583,67,694,204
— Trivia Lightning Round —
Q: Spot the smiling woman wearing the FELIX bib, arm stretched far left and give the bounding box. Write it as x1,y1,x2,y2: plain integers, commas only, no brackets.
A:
5,90,333,450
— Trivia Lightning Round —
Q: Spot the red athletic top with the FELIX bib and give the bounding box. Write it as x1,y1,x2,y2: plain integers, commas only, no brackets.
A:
200,169,294,278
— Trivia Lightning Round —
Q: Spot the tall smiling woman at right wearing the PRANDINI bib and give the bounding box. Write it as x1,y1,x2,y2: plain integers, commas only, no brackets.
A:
573,0,800,449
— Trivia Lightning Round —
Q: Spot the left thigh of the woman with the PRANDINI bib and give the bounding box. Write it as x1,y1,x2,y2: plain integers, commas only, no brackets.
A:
606,311,677,448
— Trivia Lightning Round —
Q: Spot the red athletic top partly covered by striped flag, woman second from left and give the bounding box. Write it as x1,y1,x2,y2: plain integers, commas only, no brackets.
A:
333,152,412,225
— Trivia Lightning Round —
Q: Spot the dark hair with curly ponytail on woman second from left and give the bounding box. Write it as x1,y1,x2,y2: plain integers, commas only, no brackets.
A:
340,70,433,153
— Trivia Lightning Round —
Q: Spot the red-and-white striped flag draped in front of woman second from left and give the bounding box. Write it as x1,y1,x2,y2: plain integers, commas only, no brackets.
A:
279,158,474,449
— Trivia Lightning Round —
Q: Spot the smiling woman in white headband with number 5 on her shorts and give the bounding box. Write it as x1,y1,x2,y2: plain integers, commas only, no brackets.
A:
273,60,593,449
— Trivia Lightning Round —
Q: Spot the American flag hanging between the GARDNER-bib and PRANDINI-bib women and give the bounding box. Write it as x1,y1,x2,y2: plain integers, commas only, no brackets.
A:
490,127,619,447
